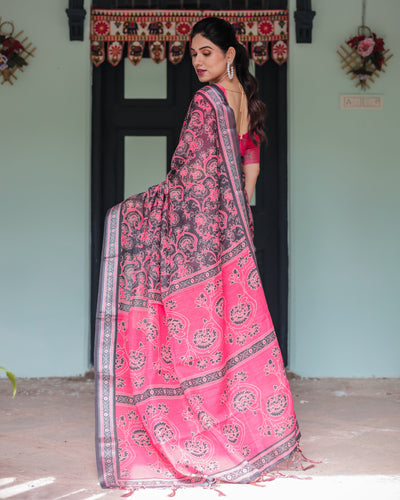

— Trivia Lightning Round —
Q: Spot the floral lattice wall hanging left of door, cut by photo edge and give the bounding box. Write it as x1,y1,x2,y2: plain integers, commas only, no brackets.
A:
0,17,36,85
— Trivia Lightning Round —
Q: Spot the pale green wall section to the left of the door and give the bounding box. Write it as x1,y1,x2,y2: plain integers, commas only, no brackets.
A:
0,0,91,377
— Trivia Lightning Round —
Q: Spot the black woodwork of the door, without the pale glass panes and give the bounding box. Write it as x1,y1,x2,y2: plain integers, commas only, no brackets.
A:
90,0,288,365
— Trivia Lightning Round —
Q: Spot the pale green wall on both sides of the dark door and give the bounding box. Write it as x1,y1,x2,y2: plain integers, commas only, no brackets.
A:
0,0,400,377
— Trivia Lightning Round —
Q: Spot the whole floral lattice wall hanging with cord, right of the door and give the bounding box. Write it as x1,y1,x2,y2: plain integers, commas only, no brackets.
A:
337,0,393,90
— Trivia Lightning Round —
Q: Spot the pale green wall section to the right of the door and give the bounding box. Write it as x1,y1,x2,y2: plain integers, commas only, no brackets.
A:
289,0,400,377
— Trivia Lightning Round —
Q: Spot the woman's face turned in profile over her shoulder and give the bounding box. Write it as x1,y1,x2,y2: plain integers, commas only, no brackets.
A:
190,35,234,83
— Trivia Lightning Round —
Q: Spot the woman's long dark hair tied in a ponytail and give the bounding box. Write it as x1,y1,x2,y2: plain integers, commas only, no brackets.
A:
190,17,266,142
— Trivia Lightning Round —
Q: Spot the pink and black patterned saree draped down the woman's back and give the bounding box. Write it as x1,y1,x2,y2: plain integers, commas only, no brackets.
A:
95,86,300,488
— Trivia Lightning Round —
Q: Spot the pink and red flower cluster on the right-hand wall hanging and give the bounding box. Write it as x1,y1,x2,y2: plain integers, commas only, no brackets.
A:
346,27,385,88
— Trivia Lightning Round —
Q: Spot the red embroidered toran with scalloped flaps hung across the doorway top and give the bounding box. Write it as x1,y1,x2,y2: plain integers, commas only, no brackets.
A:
90,9,289,66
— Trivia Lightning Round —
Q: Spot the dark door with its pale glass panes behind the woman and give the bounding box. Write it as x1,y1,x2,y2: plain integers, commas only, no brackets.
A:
91,0,288,364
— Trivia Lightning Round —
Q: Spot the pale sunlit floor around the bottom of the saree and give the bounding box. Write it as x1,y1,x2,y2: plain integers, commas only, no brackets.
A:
0,378,400,500
